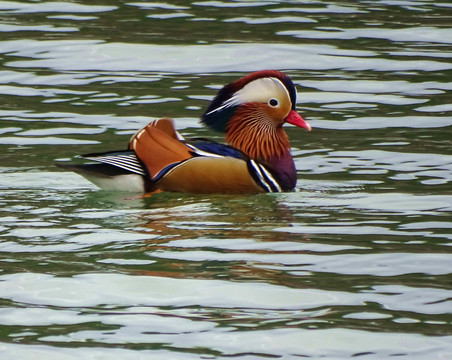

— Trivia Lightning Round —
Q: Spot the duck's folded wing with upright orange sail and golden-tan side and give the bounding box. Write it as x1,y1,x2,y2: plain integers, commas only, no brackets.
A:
130,119,262,193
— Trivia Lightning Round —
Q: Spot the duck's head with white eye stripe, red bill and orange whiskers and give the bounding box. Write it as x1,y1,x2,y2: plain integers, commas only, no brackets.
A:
201,70,311,160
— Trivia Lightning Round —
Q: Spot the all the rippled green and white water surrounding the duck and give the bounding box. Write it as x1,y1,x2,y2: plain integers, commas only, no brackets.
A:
0,0,452,360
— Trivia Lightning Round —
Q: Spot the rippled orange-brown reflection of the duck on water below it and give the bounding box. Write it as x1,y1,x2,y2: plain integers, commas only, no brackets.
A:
128,194,309,283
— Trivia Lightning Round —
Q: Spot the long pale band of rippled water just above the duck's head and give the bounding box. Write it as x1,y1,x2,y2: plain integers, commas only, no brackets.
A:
4,40,452,73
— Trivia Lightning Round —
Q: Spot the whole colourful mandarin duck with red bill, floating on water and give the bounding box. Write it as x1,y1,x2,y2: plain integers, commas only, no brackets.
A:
59,70,311,193
